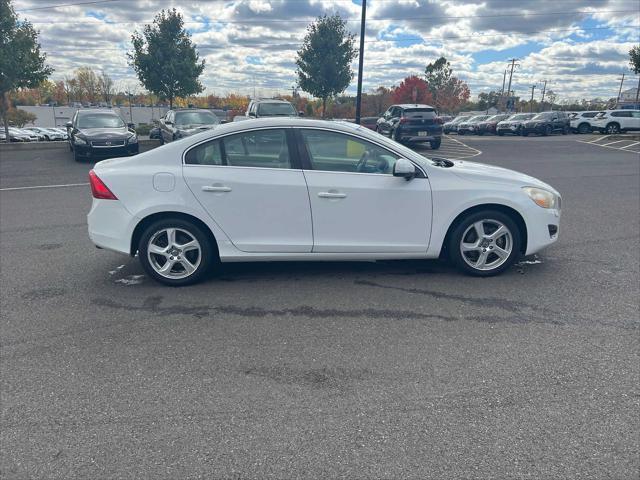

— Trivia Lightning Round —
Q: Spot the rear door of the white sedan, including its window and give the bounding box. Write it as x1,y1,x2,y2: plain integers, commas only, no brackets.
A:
183,128,313,253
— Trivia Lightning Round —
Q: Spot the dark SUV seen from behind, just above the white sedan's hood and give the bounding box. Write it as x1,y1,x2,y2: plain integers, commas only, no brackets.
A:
376,104,442,150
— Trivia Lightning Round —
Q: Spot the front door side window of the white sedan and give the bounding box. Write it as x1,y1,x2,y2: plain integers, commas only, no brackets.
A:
301,130,398,175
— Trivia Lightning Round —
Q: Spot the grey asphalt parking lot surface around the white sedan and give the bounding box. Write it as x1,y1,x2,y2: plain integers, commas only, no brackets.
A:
0,136,640,479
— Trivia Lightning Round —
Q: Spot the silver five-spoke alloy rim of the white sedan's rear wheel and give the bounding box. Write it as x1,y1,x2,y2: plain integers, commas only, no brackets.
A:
147,228,202,280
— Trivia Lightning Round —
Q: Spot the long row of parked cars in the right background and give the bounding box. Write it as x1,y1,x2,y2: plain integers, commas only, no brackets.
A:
443,109,640,137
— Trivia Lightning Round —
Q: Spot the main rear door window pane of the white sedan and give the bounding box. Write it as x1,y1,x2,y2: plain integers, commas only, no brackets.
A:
222,129,291,168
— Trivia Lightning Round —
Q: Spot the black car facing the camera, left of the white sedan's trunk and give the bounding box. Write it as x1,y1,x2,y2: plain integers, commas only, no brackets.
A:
66,109,138,162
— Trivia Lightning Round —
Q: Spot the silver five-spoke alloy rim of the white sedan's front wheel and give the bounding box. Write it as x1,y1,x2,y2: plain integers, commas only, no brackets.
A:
460,219,513,271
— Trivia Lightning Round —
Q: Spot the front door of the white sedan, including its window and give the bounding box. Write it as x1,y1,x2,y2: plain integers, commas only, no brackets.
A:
296,128,431,253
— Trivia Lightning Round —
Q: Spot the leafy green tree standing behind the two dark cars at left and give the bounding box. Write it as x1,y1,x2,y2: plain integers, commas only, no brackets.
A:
127,8,204,108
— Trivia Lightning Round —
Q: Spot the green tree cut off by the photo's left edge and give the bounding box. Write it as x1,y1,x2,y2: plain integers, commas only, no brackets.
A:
0,0,53,138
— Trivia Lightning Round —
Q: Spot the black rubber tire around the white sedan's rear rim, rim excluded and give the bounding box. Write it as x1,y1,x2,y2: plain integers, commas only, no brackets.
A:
138,218,215,287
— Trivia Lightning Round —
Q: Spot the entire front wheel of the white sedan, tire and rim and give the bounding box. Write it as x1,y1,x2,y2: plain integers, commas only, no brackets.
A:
447,210,522,277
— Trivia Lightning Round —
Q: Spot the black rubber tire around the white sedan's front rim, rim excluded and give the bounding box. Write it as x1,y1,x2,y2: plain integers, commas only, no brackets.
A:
447,210,522,277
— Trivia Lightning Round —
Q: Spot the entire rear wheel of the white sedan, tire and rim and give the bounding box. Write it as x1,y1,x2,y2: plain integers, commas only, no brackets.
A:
138,218,217,287
